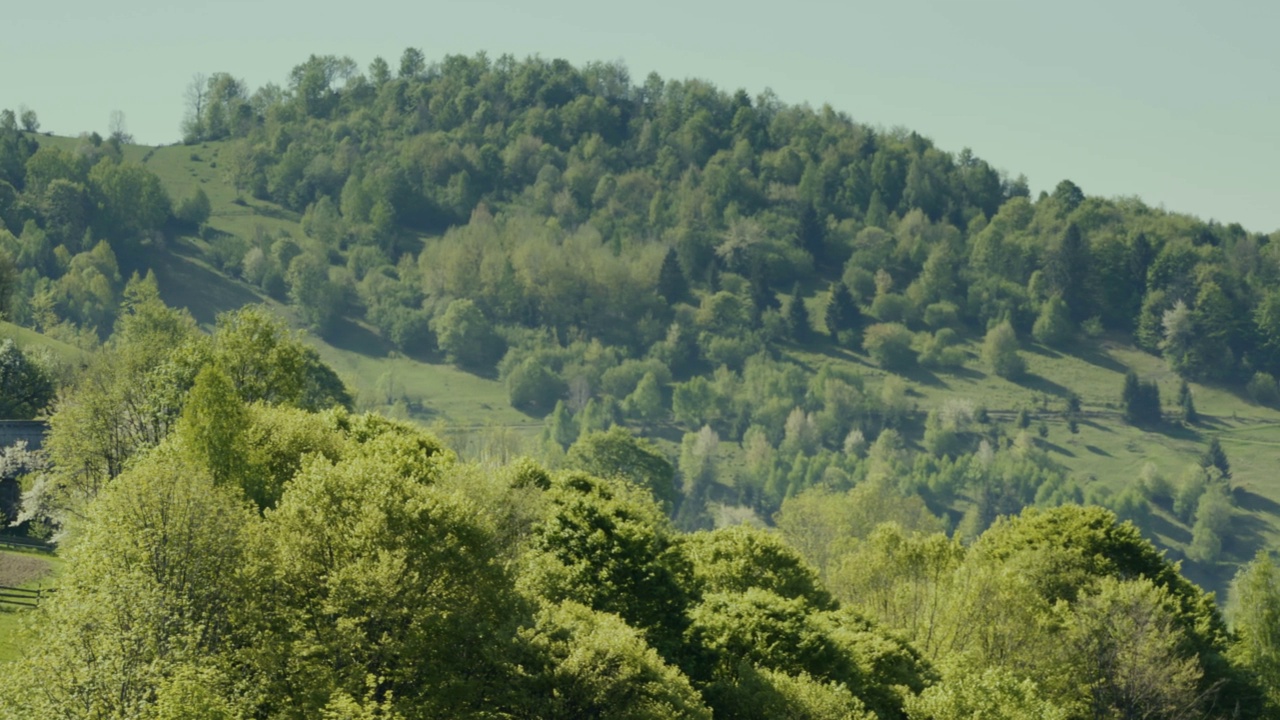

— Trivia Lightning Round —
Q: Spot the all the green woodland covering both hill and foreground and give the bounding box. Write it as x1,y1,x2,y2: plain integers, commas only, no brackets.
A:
0,49,1280,720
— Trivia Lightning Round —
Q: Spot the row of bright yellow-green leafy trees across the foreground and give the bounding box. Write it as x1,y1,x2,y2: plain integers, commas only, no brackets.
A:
0,304,1280,720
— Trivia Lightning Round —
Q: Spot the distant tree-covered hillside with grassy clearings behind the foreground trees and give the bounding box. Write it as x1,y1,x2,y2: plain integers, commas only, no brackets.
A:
0,54,1280,597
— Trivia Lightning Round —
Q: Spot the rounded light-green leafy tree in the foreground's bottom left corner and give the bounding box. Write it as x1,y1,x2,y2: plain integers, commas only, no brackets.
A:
0,447,257,717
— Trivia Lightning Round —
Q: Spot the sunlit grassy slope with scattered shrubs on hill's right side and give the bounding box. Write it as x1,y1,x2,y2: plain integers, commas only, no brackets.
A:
790,327,1280,591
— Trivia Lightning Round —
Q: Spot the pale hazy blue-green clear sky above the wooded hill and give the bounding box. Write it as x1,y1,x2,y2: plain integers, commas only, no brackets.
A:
0,0,1280,233
